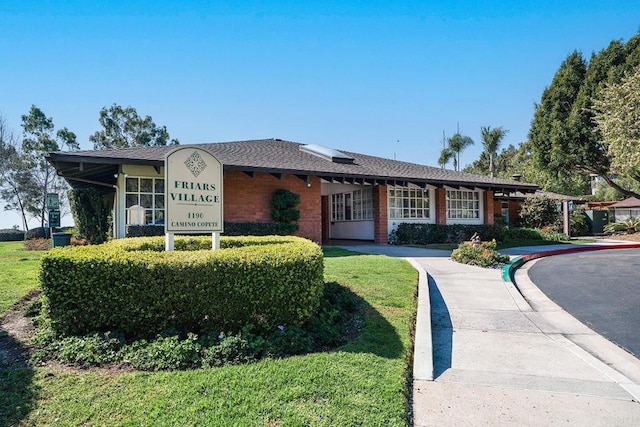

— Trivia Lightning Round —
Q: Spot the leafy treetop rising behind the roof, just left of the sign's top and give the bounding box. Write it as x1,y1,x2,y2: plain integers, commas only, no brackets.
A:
89,104,179,150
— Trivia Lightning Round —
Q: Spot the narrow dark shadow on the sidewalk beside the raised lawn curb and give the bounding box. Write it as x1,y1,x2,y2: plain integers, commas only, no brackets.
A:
427,275,453,380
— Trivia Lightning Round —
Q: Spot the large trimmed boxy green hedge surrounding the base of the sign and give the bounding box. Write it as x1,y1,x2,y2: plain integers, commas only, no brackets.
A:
40,236,324,338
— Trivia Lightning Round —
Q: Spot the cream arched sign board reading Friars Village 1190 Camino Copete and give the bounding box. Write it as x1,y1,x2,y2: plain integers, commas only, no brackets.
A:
164,146,223,234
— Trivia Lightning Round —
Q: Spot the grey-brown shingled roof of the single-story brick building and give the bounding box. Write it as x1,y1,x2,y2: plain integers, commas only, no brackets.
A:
48,139,537,192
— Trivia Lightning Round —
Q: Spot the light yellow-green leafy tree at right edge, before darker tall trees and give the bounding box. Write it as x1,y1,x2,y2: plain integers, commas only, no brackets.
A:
595,66,640,197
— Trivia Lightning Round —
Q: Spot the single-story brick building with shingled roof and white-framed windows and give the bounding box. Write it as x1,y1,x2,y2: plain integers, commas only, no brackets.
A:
48,139,538,243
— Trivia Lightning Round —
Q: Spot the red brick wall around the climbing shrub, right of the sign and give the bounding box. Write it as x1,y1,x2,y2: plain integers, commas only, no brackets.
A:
224,171,322,243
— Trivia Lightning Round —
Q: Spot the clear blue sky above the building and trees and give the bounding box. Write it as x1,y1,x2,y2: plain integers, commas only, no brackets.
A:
0,0,640,228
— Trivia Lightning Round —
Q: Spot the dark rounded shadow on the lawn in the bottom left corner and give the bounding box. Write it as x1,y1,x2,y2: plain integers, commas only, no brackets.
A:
0,329,37,427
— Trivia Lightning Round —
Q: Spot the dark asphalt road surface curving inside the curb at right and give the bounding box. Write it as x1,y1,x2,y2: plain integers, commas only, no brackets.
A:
529,249,640,357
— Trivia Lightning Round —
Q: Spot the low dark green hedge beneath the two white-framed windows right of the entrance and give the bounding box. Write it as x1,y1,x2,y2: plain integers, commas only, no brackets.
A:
394,223,504,245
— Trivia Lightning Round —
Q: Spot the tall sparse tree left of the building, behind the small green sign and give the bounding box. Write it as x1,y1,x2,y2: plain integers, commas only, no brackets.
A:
20,105,79,226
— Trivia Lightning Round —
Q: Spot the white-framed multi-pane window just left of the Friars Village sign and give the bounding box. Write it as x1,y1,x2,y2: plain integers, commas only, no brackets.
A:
125,177,164,225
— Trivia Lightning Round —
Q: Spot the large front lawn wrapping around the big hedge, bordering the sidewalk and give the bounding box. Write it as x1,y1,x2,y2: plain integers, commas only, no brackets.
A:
0,244,417,426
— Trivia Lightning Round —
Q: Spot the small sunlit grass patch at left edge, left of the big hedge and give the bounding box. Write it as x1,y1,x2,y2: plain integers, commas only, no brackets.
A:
0,242,43,315
